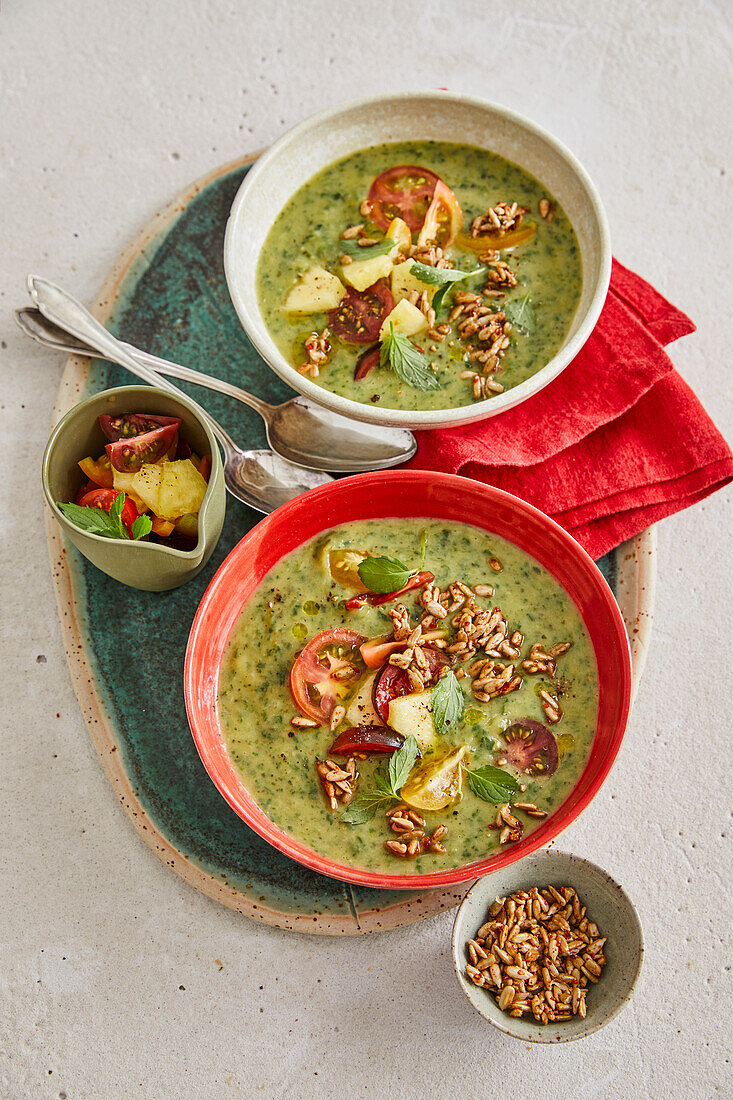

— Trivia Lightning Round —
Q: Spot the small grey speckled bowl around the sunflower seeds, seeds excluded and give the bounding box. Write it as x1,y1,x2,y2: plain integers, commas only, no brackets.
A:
451,848,644,1043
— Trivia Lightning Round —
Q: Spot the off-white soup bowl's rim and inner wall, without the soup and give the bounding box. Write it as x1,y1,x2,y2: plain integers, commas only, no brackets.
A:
223,91,611,428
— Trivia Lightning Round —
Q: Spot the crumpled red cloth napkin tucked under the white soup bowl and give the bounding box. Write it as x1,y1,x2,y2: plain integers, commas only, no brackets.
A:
407,260,733,559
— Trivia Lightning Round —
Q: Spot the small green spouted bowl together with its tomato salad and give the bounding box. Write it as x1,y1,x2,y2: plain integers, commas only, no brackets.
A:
43,386,225,591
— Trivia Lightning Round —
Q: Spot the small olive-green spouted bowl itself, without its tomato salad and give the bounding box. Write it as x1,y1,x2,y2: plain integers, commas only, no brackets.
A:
43,386,227,592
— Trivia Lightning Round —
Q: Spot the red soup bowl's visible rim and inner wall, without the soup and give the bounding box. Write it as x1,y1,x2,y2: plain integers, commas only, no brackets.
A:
184,471,632,890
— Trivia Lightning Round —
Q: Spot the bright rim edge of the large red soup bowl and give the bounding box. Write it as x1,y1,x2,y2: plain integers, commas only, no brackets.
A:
184,470,632,890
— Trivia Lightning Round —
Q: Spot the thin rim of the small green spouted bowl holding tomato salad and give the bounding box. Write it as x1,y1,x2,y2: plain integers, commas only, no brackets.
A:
41,383,222,562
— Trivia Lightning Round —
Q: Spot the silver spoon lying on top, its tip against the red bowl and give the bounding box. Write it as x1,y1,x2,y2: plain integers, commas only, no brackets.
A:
22,275,333,515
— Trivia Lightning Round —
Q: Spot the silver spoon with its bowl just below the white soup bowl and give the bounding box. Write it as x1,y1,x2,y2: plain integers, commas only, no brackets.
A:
19,281,417,473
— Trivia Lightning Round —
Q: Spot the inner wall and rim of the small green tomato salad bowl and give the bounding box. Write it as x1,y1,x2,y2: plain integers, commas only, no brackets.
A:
43,386,216,558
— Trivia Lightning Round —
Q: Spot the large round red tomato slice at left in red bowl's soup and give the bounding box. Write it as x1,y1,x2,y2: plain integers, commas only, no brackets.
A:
291,627,365,725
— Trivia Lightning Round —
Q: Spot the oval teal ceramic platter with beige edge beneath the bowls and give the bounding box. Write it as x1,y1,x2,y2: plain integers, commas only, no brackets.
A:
47,157,655,935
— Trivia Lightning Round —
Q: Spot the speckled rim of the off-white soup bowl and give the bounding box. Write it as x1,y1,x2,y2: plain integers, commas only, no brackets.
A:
223,90,612,428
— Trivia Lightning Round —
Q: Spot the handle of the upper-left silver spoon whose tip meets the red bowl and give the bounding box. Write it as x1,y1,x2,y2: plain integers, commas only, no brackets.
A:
28,275,237,453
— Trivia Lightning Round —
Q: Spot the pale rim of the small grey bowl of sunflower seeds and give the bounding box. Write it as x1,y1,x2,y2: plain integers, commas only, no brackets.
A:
450,848,644,1045
